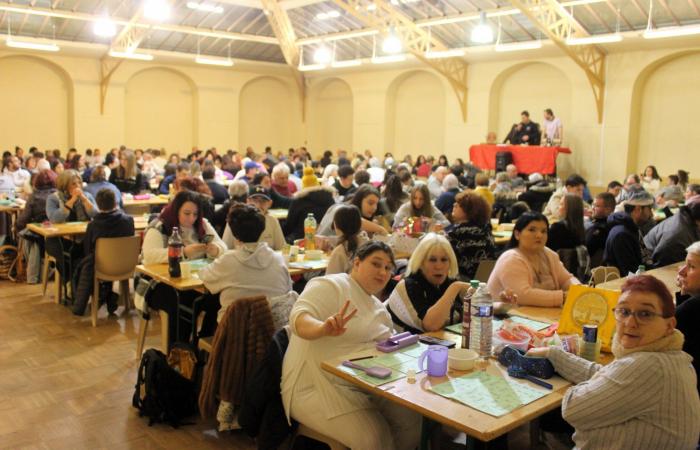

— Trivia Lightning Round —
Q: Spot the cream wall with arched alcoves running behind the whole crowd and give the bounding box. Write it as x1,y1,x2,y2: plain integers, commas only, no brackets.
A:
0,45,700,185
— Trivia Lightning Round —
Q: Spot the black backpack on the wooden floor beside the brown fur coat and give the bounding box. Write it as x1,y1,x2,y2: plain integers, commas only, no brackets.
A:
131,349,197,428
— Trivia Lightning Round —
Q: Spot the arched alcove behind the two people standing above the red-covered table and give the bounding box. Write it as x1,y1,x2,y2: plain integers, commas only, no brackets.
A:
487,62,577,147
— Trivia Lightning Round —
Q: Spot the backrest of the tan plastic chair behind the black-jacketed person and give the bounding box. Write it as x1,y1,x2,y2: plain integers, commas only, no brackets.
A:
95,236,141,281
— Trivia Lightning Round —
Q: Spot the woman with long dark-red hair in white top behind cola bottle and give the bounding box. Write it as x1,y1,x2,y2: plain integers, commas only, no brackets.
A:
141,191,226,342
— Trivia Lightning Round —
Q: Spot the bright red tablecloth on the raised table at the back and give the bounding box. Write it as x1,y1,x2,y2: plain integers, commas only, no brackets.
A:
469,144,571,174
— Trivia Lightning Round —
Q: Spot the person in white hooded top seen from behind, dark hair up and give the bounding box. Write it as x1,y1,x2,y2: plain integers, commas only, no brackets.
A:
199,204,292,320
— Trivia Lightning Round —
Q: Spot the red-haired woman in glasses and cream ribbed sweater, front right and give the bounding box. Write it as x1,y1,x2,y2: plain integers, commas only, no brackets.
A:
528,275,700,450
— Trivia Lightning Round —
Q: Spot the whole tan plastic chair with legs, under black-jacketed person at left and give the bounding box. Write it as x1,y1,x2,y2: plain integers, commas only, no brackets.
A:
92,236,141,327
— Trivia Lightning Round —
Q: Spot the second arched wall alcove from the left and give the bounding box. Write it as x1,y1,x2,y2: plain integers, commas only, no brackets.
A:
124,67,197,154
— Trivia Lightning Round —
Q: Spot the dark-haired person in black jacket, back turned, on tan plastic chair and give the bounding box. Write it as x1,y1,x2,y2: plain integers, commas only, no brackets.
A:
73,189,134,316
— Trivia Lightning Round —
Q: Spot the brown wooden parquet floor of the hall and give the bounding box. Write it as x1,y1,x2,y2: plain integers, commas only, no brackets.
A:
0,281,563,450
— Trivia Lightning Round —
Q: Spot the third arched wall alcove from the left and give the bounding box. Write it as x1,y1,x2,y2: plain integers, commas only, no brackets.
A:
238,77,297,152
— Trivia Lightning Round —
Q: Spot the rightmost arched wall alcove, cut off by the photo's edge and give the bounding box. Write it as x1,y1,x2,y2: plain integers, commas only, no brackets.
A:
627,51,700,178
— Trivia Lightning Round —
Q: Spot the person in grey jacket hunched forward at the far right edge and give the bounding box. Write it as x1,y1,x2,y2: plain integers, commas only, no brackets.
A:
644,195,700,266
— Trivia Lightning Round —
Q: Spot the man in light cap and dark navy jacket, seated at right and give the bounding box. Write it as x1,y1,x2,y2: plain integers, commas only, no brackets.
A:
603,191,654,276
